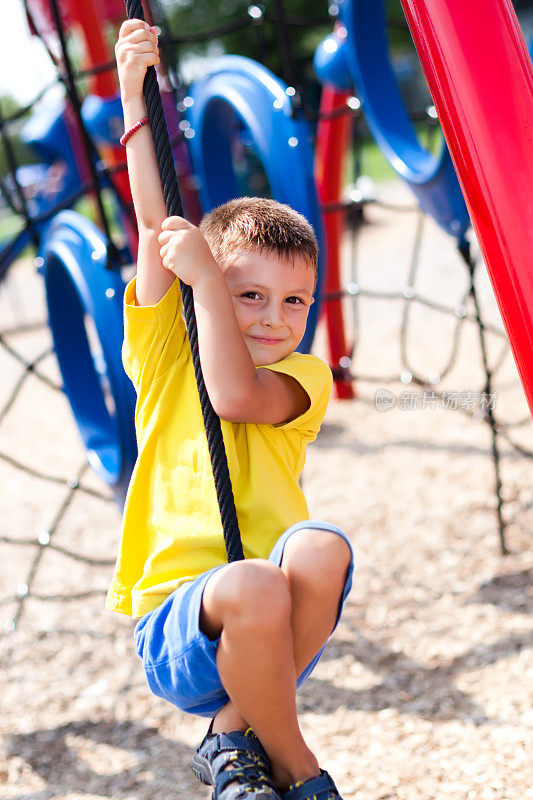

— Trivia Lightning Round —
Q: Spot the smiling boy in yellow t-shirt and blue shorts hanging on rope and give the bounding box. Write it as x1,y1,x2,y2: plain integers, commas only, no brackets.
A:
107,20,353,800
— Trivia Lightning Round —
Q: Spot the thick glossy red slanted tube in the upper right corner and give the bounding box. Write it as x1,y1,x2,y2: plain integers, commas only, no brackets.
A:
401,0,533,414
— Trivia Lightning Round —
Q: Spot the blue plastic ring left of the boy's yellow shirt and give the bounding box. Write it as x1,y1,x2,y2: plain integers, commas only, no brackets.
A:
39,211,137,504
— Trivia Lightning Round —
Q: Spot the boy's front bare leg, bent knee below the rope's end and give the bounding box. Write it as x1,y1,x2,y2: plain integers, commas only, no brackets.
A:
198,559,319,788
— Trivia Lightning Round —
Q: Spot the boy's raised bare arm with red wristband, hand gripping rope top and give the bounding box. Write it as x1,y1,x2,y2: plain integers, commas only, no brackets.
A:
115,19,174,305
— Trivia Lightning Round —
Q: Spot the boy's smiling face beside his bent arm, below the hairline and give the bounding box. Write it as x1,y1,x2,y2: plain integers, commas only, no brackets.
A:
224,250,315,367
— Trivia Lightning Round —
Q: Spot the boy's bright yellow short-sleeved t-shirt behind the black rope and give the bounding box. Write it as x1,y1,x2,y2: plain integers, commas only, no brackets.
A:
106,279,332,617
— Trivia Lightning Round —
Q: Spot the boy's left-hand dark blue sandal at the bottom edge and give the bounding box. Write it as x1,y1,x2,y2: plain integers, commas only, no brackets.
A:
191,722,280,800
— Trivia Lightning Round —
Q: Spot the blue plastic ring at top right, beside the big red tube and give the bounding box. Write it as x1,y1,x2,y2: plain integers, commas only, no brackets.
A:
315,0,470,239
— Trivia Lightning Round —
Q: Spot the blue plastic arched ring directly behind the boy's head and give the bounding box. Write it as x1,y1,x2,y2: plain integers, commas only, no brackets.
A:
183,56,326,352
